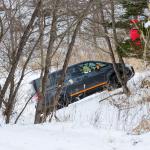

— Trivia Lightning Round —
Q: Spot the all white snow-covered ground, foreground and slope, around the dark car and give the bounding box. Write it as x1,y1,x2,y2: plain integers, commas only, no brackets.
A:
0,71,150,150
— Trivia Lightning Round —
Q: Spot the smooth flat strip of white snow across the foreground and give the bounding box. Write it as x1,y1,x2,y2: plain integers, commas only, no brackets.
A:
0,123,150,150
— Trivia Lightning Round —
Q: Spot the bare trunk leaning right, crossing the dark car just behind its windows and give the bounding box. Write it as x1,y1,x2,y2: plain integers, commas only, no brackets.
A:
35,0,94,123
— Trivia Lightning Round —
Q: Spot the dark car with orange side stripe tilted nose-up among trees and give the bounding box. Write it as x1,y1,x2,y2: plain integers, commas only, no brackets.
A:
32,61,134,108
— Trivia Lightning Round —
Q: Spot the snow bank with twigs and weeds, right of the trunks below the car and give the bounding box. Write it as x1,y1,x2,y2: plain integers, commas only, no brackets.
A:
57,71,150,131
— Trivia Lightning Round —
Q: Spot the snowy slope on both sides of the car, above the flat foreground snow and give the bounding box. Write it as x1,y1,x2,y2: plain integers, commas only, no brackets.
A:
9,71,150,131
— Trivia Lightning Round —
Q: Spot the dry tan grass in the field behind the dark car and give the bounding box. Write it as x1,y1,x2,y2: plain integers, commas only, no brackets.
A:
20,39,144,71
